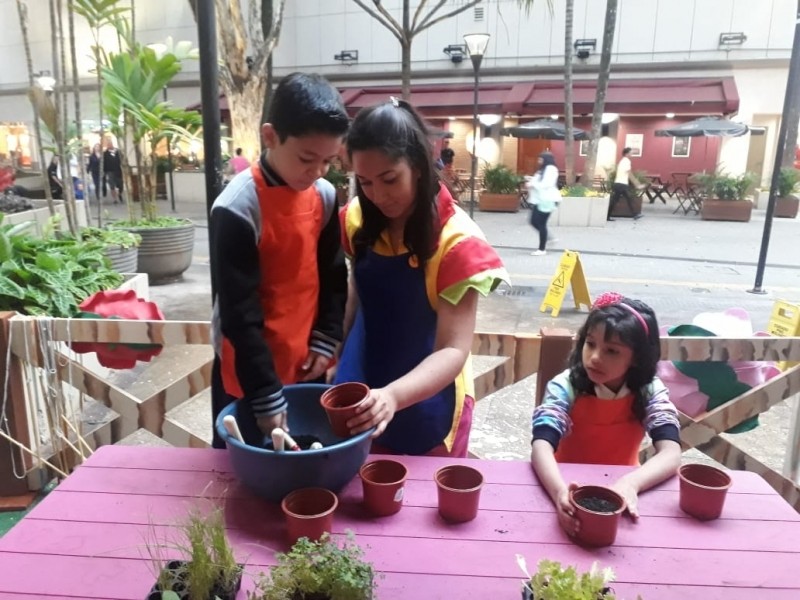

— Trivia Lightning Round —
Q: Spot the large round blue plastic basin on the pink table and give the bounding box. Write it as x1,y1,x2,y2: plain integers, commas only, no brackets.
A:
215,384,373,502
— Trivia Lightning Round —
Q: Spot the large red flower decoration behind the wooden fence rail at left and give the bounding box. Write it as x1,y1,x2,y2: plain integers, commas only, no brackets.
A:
71,290,164,369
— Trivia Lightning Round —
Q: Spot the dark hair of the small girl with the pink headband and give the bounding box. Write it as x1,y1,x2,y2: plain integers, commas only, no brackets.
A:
569,298,661,419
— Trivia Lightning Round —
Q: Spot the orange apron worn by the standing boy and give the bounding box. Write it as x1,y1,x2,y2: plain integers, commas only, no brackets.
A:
222,162,324,398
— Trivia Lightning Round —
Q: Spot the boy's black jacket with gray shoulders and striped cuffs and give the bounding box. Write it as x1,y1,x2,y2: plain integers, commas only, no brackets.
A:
209,156,347,417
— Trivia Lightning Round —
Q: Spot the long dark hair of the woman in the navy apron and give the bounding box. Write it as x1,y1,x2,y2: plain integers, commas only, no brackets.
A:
347,100,439,268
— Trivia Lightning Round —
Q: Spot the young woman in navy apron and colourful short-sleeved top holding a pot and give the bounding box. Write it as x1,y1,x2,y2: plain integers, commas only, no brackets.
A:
335,99,507,457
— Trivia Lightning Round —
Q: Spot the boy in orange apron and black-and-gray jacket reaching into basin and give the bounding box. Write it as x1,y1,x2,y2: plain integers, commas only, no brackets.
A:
209,73,349,448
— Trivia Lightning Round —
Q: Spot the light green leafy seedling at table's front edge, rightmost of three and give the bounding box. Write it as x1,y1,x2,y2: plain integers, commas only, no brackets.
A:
517,554,616,600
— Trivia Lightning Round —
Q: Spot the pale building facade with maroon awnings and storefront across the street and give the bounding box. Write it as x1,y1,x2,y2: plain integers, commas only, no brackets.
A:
0,0,796,180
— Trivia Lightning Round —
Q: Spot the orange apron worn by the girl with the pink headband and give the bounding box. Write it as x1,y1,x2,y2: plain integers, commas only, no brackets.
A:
556,394,644,466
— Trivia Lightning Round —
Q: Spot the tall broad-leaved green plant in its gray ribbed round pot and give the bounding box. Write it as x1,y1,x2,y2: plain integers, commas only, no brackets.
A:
101,24,201,282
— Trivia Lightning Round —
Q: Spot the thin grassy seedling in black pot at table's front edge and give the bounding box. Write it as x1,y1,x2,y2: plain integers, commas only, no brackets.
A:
146,507,243,600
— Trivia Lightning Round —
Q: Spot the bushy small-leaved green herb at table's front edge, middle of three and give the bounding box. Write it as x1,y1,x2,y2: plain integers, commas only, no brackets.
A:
247,531,377,600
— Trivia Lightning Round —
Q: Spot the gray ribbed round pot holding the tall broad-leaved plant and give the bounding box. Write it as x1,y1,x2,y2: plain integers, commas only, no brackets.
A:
125,222,194,283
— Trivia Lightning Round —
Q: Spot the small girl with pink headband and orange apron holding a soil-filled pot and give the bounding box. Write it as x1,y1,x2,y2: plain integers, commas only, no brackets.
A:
531,294,681,535
